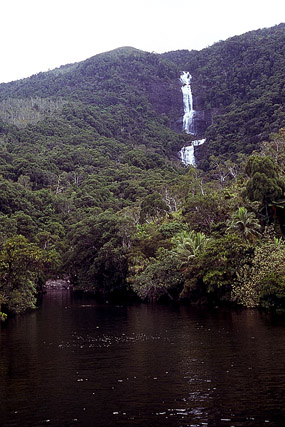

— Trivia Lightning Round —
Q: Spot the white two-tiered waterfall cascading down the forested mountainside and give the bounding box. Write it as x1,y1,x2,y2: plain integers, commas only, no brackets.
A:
179,71,206,166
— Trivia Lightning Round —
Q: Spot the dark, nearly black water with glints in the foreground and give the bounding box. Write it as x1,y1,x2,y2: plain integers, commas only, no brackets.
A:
0,291,285,426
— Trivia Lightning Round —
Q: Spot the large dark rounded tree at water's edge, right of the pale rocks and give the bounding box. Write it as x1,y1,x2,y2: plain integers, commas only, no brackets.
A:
65,211,134,296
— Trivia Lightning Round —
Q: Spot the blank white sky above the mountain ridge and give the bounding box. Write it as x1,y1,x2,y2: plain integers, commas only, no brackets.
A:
0,0,285,82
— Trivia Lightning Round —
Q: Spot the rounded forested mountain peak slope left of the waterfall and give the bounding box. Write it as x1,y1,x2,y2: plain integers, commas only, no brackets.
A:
0,48,181,130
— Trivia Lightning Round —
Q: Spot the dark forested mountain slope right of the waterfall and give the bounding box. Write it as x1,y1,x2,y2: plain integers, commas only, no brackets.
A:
163,24,285,166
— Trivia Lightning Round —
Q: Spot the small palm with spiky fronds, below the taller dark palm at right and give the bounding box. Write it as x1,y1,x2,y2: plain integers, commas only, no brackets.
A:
227,207,261,241
